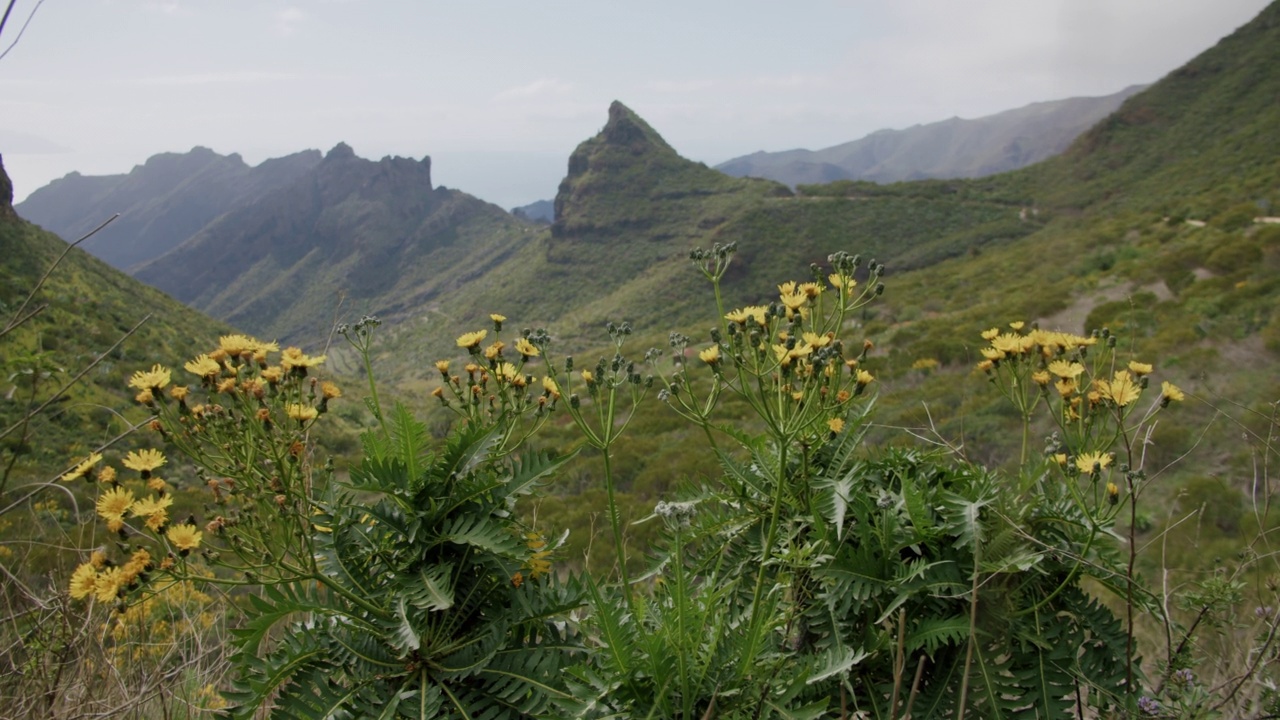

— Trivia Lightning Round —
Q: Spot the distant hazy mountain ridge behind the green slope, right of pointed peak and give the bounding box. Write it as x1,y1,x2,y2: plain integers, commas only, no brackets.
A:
716,86,1143,187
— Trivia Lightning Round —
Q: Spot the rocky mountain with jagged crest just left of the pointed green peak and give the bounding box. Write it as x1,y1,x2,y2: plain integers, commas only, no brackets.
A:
124,143,534,342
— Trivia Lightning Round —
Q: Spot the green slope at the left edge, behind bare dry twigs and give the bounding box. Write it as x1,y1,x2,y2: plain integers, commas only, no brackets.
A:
0,151,230,476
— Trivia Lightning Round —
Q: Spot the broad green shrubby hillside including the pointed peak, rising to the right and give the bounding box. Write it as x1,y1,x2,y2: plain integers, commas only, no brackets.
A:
385,5,1280,566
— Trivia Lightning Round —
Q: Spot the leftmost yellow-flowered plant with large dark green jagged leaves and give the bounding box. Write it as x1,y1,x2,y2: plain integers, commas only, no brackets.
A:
60,326,579,719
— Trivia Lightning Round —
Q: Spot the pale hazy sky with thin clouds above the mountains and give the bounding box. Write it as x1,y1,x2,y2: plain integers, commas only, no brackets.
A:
0,0,1266,208
